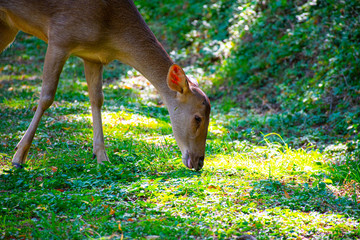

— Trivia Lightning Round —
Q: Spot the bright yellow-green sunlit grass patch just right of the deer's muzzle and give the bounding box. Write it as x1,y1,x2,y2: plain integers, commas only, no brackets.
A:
207,137,326,180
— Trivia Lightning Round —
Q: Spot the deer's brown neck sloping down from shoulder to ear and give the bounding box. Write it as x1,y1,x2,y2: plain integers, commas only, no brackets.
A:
108,1,176,107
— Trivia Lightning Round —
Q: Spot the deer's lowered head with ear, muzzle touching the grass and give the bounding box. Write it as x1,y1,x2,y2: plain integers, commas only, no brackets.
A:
167,64,211,171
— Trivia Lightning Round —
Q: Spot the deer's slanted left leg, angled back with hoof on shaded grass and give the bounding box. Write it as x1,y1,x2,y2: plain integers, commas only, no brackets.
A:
12,43,68,168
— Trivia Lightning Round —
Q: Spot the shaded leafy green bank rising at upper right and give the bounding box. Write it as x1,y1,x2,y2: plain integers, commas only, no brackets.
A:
216,1,360,141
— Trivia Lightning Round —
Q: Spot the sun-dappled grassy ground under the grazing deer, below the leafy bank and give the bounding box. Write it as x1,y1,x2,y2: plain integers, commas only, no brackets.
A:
0,32,360,239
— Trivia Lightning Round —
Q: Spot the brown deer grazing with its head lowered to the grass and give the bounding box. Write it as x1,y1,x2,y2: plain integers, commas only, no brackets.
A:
0,0,211,171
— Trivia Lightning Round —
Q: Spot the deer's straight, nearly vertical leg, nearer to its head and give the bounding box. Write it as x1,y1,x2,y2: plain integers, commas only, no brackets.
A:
84,60,109,163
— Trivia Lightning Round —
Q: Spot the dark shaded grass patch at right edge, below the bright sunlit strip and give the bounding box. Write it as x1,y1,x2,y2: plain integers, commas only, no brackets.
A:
250,179,360,219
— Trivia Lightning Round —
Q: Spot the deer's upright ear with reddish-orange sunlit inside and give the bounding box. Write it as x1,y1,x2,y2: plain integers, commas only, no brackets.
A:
167,64,189,94
